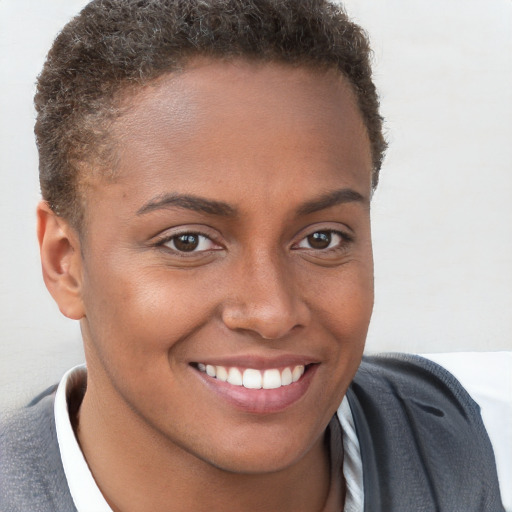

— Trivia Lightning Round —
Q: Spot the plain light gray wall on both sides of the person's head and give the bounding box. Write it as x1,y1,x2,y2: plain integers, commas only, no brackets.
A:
0,0,512,406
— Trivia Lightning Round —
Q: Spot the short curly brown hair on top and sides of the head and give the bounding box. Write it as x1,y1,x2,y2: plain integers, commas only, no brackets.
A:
35,0,386,228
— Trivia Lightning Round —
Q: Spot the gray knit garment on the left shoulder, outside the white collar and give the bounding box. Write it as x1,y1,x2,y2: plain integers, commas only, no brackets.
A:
0,386,74,512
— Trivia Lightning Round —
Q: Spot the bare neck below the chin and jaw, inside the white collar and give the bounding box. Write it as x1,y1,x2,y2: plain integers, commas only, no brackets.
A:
77,374,341,512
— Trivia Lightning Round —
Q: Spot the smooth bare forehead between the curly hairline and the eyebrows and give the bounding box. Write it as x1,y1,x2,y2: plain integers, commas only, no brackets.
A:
88,58,371,216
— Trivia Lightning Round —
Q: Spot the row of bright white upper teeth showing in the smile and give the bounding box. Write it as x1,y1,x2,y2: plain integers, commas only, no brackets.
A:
197,363,304,389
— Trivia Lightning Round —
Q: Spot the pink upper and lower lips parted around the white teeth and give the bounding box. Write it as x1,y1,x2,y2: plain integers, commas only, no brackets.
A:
189,356,319,415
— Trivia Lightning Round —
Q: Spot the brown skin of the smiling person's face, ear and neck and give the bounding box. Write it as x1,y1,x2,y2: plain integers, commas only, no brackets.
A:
38,59,373,512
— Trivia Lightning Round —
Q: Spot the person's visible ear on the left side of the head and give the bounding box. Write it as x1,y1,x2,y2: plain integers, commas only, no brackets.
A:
37,201,85,320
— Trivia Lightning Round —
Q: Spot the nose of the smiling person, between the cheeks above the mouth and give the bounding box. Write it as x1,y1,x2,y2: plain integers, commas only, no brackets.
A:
222,255,310,340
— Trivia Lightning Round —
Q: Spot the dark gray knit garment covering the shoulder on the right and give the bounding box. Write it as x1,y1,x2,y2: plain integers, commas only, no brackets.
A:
347,354,503,512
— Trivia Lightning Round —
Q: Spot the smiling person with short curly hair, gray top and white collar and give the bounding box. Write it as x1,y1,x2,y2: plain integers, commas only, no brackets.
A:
0,0,503,511
